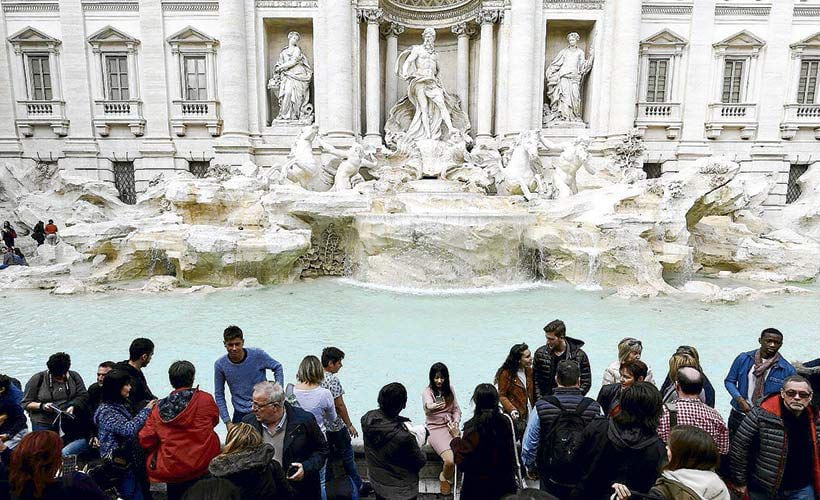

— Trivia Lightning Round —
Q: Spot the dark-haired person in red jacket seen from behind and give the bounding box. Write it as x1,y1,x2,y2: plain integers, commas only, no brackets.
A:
139,361,219,500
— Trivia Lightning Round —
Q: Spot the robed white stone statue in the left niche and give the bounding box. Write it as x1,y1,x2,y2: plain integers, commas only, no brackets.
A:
268,31,313,123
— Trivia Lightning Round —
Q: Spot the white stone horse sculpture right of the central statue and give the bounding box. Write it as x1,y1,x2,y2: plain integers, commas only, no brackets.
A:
492,130,552,201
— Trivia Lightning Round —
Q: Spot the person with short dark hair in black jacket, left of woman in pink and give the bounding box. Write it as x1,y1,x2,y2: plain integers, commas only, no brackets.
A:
362,382,427,500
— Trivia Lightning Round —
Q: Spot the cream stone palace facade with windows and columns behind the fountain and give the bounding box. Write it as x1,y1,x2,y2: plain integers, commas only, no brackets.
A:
0,0,820,210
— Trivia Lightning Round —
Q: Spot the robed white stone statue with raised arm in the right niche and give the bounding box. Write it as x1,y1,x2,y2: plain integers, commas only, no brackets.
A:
545,32,594,123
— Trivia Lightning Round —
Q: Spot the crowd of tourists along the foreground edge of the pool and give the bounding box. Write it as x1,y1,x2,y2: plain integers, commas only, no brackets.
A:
0,320,820,500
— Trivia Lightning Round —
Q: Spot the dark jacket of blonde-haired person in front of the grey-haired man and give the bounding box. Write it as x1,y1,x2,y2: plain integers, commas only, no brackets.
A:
208,444,294,500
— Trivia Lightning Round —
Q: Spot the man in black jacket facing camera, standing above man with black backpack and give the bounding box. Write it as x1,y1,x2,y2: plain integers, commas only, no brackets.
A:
533,319,592,399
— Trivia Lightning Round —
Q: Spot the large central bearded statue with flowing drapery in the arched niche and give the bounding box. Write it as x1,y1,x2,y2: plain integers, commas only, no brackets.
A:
384,28,470,150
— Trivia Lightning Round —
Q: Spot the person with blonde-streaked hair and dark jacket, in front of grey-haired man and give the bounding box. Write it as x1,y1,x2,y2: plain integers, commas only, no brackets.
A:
208,423,293,500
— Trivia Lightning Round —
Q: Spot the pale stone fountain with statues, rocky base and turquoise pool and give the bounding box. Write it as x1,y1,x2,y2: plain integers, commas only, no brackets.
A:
0,2,820,419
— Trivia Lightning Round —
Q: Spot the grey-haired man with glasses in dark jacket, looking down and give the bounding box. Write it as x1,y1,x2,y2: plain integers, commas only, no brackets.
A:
242,381,328,500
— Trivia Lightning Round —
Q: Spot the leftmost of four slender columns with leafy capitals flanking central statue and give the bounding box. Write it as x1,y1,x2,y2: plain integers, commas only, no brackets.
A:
359,9,382,146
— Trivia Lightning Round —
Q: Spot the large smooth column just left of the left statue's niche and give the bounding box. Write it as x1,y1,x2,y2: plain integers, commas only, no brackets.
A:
214,0,251,165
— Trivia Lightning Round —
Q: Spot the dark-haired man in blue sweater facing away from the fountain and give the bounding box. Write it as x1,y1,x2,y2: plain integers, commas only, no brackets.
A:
214,325,285,429
